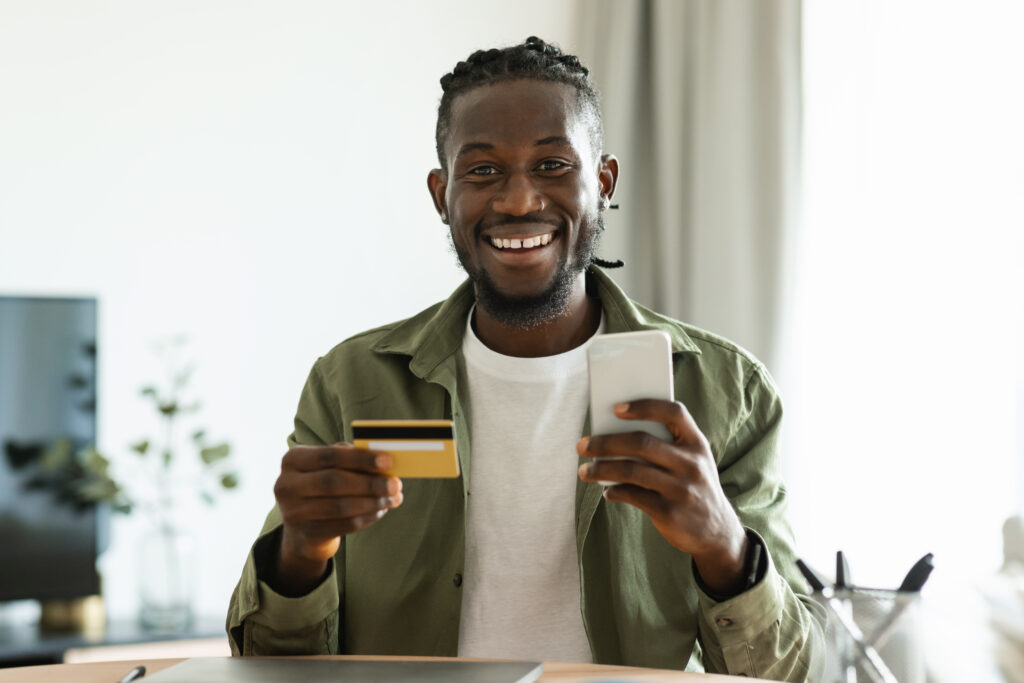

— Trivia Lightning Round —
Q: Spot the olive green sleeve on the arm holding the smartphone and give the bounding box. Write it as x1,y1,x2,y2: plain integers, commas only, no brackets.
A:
697,366,825,681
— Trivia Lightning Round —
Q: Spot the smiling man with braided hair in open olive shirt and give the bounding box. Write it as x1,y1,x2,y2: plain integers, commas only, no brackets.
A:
227,38,822,680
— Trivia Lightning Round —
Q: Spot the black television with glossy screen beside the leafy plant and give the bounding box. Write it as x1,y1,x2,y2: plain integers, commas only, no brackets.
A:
0,296,103,602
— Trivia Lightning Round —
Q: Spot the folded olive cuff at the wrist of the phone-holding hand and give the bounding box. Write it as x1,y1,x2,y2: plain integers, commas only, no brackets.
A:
693,528,785,647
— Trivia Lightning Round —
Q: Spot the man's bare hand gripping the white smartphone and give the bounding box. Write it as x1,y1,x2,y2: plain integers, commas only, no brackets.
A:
577,399,749,595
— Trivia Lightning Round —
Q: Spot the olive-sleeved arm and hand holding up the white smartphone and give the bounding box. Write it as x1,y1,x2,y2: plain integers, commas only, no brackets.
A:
579,366,824,681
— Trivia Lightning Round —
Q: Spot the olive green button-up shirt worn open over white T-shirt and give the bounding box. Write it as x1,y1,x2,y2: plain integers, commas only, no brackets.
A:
227,269,824,681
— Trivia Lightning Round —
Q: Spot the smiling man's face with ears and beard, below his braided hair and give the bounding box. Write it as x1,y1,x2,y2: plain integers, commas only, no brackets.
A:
430,80,617,328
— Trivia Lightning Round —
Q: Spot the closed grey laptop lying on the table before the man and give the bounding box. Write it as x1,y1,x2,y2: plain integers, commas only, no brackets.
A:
143,657,544,683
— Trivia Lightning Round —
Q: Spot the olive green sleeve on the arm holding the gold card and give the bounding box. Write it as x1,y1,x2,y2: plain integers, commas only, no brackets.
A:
226,364,345,656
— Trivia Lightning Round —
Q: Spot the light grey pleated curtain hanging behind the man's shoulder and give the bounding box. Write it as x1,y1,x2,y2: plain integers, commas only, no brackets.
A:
578,0,801,367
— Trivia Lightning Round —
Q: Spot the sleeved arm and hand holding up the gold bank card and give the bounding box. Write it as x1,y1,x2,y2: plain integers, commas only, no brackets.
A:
226,366,401,655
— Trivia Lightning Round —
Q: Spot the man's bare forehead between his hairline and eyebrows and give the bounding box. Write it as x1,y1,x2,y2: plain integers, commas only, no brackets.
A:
446,80,589,159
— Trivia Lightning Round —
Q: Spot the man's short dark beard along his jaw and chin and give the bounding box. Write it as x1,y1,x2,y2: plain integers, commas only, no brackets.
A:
449,212,604,330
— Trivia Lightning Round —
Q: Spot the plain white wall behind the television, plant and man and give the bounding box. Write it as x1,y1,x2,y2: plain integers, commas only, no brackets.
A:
0,0,573,617
